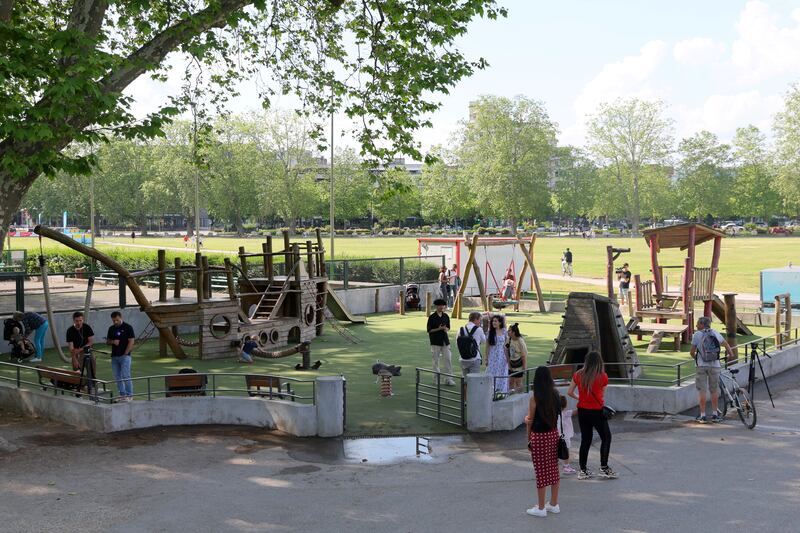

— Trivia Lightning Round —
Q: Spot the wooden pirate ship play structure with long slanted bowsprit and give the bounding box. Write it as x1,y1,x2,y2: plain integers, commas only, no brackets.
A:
34,226,364,368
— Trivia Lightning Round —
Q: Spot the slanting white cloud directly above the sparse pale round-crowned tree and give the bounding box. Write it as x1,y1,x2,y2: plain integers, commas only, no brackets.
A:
574,41,667,119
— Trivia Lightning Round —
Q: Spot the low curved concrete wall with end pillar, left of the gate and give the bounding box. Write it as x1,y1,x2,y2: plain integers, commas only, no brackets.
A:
0,376,344,437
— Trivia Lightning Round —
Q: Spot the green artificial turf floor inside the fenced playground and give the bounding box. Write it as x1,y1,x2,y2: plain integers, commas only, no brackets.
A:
0,306,770,435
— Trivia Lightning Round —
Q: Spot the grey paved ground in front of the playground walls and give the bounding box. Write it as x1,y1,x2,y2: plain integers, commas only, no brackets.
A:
0,371,800,533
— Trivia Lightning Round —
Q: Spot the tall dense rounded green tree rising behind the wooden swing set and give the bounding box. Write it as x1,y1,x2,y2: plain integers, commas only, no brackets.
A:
459,96,556,233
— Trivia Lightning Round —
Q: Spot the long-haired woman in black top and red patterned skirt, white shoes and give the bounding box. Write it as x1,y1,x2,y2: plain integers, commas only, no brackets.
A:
525,366,561,516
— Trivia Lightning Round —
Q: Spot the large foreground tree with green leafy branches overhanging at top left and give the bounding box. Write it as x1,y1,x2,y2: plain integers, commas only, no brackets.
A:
0,0,505,250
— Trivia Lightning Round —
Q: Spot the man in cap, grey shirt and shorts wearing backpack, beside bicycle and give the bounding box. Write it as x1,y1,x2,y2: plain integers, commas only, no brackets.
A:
691,316,731,424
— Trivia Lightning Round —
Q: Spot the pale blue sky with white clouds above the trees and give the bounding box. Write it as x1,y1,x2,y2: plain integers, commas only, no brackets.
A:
129,0,800,156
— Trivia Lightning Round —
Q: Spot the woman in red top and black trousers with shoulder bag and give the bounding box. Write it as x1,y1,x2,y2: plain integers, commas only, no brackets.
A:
567,351,617,479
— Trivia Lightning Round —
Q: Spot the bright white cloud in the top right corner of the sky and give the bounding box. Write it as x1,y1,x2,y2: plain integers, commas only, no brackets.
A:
731,0,800,83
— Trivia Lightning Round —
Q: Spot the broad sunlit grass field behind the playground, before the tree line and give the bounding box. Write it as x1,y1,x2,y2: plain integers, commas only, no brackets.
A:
11,233,800,295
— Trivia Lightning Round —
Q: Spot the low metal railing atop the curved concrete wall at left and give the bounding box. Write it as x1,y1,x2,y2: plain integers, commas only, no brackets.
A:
0,361,316,405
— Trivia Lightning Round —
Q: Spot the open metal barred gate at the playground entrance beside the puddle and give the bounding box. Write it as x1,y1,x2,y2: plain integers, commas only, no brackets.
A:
415,368,467,427
